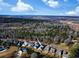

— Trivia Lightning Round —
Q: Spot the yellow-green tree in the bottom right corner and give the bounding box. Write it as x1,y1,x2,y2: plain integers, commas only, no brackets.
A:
69,43,79,58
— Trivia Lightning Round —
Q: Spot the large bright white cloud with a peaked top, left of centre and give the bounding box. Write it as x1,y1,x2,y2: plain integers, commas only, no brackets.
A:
11,0,34,12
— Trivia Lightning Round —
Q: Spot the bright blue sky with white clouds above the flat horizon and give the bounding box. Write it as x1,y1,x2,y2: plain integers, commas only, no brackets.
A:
0,0,79,16
